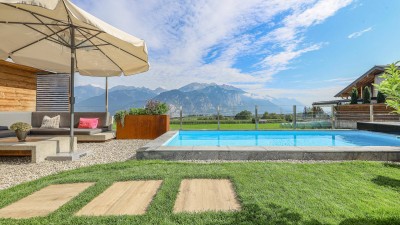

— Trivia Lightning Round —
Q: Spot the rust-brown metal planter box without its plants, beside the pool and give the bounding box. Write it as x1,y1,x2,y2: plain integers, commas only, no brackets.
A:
117,115,169,139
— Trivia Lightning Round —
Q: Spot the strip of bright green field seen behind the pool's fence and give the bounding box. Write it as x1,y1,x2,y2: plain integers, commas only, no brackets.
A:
170,123,282,130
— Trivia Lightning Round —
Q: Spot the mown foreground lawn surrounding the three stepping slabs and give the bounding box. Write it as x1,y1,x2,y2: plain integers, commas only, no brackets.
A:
0,161,400,225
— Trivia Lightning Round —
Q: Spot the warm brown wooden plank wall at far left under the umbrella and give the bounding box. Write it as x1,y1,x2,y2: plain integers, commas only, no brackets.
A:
0,61,39,112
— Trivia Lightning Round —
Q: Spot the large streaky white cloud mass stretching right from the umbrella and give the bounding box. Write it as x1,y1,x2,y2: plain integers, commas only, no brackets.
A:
74,0,352,103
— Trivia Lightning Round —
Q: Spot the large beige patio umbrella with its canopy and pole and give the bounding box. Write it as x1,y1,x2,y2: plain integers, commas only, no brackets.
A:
0,0,149,152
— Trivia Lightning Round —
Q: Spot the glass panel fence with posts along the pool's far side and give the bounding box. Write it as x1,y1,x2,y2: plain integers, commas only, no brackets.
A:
170,105,334,130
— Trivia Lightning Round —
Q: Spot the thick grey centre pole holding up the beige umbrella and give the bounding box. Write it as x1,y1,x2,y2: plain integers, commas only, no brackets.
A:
69,25,75,153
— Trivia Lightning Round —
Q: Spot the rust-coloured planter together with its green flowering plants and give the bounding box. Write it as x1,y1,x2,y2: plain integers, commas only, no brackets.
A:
114,100,170,139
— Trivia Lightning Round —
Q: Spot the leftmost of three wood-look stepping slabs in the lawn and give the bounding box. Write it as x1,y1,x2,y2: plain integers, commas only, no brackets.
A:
0,183,94,219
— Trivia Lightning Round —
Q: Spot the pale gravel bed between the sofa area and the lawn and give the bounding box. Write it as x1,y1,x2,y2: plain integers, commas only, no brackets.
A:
0,140,148,190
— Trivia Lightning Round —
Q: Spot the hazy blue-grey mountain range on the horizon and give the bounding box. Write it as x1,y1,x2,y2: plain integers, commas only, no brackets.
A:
75,83,303,116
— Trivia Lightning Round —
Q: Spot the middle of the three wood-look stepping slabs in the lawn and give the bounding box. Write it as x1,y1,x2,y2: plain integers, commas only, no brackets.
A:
76,180,162,216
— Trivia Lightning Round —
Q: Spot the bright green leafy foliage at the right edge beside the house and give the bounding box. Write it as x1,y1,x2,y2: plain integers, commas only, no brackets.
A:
375,61,400,114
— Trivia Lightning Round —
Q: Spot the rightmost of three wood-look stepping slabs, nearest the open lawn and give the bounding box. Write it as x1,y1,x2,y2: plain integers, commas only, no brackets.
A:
174,179,240,212
